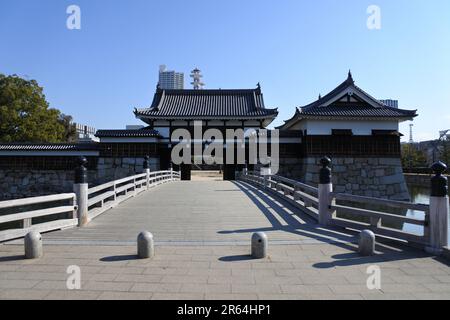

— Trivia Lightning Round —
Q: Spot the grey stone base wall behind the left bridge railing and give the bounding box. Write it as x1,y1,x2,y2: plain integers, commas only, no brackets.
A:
0,158,159,201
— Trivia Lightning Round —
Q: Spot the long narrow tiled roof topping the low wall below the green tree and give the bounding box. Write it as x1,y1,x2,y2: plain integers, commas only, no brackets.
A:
0,143,98,151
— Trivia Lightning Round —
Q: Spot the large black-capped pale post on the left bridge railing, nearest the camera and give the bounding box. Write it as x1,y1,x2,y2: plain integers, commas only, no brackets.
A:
73,157,89,227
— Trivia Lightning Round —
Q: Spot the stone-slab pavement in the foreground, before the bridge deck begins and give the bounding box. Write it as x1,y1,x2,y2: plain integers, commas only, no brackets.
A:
0,244,450,300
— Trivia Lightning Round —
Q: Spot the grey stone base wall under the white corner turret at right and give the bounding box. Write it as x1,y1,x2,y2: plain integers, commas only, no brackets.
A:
280,157,410,201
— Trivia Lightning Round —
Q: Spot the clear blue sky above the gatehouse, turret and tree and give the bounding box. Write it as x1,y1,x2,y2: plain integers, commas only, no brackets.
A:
0,0,450,140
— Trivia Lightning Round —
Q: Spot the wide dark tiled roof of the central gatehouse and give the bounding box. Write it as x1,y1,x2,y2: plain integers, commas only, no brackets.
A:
135,87,278,119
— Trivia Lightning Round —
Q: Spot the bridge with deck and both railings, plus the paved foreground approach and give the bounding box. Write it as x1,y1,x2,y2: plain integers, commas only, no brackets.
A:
0,162,450,299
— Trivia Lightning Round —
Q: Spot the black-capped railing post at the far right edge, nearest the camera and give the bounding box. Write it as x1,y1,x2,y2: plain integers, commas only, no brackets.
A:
425,161,449,255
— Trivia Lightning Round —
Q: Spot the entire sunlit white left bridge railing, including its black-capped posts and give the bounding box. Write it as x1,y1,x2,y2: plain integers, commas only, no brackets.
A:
0,157,181,242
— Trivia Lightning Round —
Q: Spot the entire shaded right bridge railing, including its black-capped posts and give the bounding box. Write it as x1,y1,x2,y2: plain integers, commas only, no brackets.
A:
238,158,449,253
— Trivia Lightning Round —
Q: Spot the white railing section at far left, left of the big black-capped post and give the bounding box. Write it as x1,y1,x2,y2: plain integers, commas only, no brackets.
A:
0,193,78,242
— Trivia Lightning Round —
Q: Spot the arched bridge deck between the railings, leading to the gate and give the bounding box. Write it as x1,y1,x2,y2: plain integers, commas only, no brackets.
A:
38,181,354,244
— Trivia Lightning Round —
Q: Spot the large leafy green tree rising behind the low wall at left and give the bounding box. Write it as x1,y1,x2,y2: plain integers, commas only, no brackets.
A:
0,74,74,143
